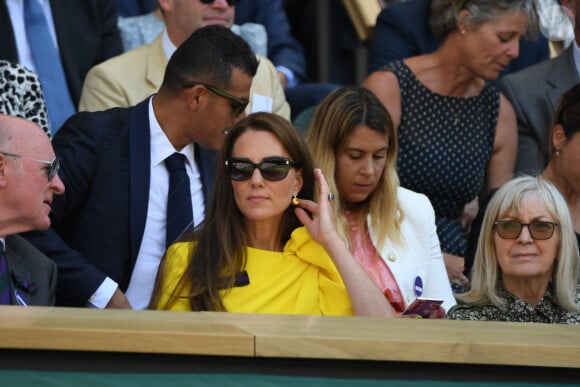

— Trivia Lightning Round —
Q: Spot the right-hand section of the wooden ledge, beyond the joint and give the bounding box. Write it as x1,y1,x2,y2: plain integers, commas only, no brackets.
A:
206,314,580,368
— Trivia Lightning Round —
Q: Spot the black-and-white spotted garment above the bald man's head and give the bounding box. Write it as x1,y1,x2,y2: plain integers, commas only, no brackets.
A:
0,60,50,137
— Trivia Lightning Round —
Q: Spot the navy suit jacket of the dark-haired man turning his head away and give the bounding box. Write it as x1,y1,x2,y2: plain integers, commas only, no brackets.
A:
21,99,216,306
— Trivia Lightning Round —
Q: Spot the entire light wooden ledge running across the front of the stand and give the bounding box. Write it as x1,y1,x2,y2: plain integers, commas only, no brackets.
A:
0,306,580,368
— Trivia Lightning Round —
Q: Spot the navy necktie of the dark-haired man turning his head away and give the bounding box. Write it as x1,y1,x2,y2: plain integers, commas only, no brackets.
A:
165,153,193,247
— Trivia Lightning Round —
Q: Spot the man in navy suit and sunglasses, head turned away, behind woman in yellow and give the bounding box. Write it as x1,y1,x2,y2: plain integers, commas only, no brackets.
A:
22,26,258,309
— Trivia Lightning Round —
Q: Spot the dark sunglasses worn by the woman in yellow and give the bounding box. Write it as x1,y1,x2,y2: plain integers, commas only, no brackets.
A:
226,157,295,181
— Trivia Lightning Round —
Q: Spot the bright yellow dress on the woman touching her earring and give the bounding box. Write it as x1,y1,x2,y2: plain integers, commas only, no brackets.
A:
157,227,353,316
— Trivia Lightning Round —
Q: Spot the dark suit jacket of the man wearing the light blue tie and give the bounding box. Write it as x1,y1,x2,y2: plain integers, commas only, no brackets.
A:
0,0,123,106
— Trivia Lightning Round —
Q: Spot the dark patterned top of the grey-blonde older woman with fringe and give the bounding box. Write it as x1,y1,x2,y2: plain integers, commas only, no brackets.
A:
446,287,580,324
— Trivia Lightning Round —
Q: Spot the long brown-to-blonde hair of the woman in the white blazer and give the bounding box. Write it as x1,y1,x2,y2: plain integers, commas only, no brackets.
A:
306,86,403,250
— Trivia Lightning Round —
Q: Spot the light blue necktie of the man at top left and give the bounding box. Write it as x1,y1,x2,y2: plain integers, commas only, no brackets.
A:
24,0,76,134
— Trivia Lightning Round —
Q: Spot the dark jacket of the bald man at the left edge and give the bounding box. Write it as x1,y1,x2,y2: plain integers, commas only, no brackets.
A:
6,235,57,306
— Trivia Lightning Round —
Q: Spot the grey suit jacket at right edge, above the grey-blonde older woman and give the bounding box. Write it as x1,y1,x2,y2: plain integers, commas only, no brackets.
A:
499,44,580,174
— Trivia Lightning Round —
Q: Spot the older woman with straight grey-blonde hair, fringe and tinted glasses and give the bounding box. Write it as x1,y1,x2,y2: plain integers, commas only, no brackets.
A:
447,176,580,324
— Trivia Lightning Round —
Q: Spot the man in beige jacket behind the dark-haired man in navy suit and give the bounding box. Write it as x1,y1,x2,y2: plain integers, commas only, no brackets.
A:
79,0,290,118
